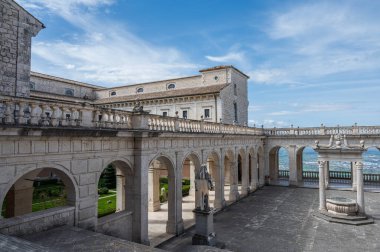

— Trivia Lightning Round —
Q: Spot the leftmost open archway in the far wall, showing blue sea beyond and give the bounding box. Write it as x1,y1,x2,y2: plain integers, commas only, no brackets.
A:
268,146,289,186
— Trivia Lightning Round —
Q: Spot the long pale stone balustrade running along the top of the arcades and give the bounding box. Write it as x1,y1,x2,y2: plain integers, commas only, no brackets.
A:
0,96,380,136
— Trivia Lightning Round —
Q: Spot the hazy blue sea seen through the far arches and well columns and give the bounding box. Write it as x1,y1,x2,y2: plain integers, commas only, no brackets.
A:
279,147,380,174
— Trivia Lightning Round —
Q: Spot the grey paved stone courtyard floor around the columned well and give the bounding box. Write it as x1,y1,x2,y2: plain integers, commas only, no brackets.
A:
160,186,380,252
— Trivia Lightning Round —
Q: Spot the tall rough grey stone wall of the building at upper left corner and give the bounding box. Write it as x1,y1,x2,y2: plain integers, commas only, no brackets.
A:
0,0,43,97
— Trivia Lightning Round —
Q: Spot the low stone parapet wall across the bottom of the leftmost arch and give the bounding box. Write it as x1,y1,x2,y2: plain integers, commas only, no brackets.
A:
0,207,75,236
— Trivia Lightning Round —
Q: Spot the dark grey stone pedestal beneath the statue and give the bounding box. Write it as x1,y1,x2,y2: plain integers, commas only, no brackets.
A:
193,209,216,246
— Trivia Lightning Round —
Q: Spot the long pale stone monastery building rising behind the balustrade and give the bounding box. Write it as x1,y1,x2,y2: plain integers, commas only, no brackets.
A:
30,66,249,125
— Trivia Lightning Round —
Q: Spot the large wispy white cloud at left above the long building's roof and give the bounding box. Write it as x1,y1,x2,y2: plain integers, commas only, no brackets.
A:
16,0,199,86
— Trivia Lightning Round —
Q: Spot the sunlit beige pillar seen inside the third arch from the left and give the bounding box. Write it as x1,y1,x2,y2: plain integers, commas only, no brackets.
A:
148,167,161,212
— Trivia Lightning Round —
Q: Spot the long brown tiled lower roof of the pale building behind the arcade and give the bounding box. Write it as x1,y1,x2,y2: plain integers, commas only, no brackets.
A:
95,84,228,104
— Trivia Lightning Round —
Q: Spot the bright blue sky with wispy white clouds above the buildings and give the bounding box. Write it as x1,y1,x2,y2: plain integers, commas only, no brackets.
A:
17,0,380,127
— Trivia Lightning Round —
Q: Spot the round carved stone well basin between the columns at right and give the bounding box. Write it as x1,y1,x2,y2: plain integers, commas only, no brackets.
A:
326,197,358,216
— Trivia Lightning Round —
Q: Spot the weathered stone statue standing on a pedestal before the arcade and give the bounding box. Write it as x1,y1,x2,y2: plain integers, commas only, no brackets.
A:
195,164,213,211
